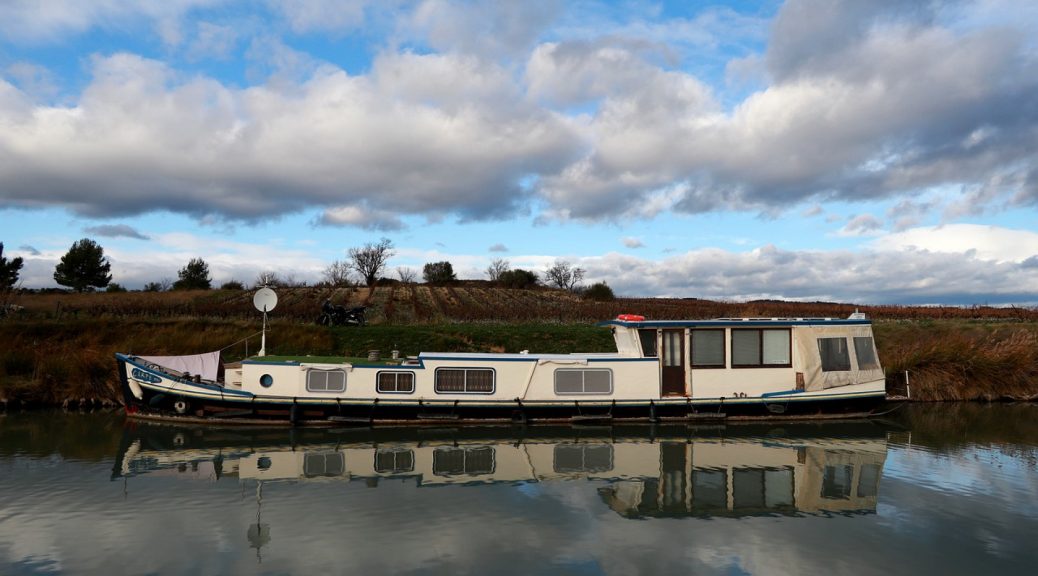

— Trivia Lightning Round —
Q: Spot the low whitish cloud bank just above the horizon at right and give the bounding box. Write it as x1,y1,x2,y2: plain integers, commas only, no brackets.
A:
574,241,1038,304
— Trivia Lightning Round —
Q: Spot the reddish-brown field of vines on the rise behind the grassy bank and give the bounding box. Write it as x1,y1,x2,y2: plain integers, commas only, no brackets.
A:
13,281,1038,325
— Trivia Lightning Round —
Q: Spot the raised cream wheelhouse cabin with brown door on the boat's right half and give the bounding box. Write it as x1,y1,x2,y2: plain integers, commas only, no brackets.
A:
599,312,883,397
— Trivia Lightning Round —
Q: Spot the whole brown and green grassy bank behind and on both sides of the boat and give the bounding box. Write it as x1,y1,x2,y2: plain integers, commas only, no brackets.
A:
0,317,1038,405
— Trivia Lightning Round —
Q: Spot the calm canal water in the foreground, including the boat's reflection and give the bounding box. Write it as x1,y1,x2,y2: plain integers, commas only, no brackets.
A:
0,405,1038,575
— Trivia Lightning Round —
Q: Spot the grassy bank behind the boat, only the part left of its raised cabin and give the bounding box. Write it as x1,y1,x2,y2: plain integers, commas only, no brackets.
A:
0,318,613,404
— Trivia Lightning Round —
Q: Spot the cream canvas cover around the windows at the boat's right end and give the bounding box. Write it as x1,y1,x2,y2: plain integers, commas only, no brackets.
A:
794,325,883,391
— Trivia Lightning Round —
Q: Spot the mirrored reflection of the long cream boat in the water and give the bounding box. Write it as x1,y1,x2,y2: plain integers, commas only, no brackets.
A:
112,422,886,518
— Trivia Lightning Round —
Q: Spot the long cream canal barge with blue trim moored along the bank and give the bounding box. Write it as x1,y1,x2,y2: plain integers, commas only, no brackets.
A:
115,312,885,426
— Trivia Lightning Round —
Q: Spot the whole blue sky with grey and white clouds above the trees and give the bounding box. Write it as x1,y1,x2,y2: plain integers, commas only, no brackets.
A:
0,0,1038,305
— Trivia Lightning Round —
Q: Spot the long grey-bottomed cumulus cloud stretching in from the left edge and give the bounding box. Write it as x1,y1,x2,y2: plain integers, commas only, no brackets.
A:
0,54,576,224
